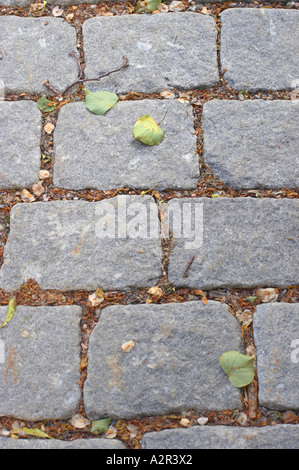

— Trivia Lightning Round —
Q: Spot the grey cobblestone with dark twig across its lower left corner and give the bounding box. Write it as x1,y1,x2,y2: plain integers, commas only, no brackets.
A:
83,12,219,93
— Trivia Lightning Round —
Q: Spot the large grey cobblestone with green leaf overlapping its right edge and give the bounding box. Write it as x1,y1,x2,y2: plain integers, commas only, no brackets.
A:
84,301,243,418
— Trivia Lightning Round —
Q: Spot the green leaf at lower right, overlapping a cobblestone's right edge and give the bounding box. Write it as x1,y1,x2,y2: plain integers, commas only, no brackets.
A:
219,351,254,388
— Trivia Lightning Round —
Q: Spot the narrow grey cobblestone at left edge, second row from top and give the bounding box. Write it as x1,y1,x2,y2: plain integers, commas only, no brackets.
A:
0,102,41,189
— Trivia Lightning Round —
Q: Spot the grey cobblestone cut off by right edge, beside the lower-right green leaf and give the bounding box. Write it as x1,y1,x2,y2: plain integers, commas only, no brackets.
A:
253,302,299,410
